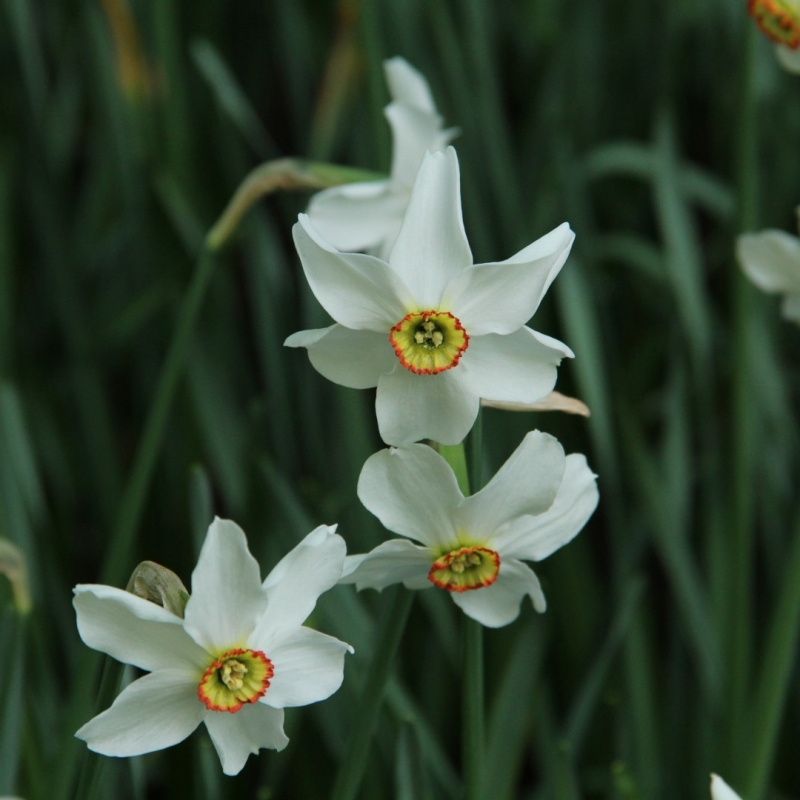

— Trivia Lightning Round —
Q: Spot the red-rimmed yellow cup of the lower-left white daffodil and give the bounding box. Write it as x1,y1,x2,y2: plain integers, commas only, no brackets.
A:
197,649,275,714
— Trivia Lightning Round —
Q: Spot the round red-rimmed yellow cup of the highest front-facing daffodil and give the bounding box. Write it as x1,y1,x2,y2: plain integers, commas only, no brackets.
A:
389,311,469,375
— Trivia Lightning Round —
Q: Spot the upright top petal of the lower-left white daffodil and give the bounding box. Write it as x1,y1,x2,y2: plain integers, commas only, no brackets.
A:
184,517,267,652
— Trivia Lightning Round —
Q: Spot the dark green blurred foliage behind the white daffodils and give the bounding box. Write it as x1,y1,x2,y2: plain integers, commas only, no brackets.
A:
0,0,800,800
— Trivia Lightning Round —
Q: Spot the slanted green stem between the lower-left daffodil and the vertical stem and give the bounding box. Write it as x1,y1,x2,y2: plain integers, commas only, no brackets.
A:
331,586,414,800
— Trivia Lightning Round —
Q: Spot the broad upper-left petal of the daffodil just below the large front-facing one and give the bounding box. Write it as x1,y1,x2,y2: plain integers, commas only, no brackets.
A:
357,444,464,546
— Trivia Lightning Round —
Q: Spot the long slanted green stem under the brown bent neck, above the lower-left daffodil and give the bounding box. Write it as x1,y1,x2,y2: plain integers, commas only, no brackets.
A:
102,250,215,586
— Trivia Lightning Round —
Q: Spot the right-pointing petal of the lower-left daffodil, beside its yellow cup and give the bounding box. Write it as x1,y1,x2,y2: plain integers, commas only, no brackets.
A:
261,627,353,708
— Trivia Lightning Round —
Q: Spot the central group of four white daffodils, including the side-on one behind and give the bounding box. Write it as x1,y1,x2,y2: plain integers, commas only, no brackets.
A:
74,59,598,775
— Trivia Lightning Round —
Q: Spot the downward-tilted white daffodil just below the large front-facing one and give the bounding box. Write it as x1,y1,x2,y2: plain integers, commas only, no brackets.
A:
340,431,598,628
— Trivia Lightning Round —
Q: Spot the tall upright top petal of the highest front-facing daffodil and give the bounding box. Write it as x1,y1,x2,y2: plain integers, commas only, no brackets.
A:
390,147,476,308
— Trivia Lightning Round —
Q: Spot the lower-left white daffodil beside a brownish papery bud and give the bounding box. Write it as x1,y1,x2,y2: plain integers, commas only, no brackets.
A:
73,519,352,775
